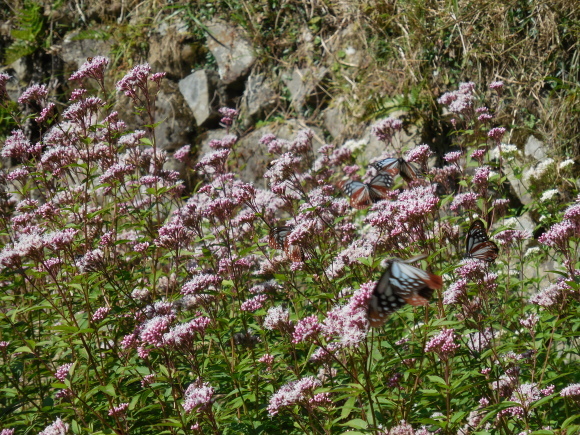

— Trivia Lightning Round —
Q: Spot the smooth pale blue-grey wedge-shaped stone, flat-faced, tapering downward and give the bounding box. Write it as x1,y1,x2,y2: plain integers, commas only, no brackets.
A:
179,70,219,125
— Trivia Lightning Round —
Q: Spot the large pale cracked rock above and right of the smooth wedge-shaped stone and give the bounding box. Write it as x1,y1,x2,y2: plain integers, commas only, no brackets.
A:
206,20,256,85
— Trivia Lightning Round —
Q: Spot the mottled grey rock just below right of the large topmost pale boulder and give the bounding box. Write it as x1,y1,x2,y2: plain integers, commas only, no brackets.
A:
240,74,278,127
